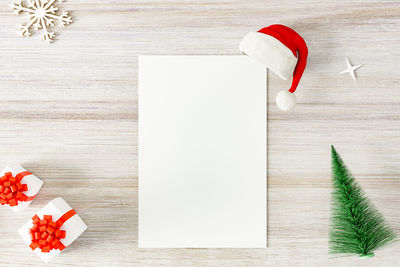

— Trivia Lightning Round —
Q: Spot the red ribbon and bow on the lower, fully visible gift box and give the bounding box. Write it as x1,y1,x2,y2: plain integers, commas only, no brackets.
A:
29,209,76,252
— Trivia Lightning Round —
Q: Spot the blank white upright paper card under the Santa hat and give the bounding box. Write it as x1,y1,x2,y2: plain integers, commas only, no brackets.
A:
138,56,267,248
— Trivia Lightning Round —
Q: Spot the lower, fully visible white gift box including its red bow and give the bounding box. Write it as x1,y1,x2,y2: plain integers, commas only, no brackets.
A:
18,198,87,262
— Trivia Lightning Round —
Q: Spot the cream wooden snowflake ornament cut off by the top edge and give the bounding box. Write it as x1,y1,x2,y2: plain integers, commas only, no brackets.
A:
10,0,72,43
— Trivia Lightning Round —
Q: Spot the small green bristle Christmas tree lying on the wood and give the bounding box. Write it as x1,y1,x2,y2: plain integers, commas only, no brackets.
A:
330,146,397,258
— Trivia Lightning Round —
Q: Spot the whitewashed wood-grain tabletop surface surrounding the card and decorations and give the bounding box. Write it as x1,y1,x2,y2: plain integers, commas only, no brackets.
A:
0,0,400,266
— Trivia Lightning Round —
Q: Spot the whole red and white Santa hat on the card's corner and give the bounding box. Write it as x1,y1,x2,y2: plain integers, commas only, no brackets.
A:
239,24,308,111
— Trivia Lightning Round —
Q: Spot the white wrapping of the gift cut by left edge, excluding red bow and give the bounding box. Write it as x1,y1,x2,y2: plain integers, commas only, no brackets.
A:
0,165,43,212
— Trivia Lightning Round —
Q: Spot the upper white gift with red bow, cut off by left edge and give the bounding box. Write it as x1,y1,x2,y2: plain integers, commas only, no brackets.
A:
0,165,43,212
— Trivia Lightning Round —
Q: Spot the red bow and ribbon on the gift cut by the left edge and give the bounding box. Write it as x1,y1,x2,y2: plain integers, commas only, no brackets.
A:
0,171,36,207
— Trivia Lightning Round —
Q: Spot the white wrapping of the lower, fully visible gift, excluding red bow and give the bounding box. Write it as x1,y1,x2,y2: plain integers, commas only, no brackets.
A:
18,198,87,263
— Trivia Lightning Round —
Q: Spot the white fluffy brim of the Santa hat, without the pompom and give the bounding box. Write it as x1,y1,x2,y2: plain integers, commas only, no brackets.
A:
239,32,297,80
